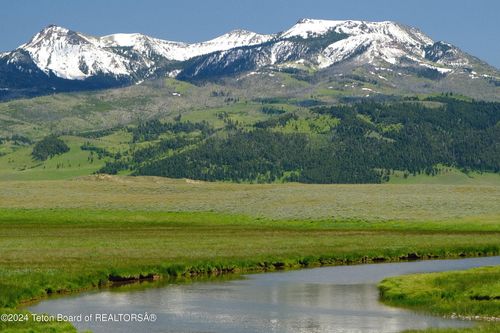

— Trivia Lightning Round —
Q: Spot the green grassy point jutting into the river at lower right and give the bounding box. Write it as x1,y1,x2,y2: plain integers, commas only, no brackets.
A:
379,266,500,333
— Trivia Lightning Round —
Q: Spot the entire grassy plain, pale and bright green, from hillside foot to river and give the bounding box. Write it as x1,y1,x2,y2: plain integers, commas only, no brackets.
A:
0,174,500,332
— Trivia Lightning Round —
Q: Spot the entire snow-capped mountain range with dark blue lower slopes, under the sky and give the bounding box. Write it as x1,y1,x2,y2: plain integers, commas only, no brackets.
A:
0,19,496,97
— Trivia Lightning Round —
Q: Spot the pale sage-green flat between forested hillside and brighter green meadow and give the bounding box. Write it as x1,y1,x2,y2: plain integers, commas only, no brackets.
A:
0,175,500,220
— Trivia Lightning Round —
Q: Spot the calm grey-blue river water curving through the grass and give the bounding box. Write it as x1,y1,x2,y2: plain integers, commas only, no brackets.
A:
29,257,500,333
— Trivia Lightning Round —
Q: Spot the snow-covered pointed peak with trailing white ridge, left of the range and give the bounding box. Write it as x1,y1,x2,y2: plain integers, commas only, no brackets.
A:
2,25,272,80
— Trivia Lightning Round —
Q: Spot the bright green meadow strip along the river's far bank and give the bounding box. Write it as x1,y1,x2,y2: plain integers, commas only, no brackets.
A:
0,209,500,330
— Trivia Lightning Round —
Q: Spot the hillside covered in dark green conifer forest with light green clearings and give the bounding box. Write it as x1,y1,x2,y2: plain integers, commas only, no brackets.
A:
110,96,500,183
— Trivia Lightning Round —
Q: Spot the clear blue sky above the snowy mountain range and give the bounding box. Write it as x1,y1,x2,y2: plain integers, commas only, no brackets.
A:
0,0,500,68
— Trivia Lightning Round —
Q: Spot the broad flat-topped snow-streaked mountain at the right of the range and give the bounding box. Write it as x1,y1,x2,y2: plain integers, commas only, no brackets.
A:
180,19,488,78
